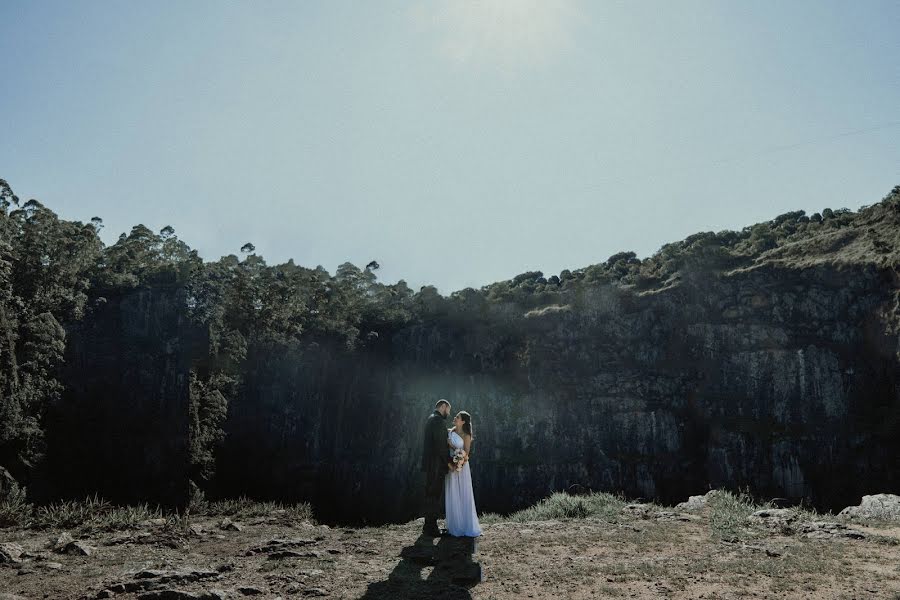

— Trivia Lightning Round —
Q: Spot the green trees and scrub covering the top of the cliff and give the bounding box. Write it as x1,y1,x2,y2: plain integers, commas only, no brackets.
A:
0,179,900,496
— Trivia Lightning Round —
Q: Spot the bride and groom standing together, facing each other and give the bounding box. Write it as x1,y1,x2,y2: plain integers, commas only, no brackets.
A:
422,400,481,537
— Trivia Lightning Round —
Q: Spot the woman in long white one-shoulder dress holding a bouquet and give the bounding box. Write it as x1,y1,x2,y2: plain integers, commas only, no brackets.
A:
444,411,481,537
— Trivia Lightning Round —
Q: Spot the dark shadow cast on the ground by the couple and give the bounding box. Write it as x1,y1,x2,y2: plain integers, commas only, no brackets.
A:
361,535,481,600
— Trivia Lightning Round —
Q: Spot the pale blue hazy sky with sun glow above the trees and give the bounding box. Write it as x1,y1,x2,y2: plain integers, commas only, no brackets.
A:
0,0,900,294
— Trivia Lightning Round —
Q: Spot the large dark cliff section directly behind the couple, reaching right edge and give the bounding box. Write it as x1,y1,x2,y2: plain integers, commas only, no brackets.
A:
213,261,900,521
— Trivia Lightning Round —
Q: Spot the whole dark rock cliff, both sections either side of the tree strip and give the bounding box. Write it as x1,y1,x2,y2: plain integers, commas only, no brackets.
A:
29,198,900,522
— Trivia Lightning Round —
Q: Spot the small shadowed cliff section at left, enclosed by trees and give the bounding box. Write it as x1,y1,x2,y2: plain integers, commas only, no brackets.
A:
39,286,194,505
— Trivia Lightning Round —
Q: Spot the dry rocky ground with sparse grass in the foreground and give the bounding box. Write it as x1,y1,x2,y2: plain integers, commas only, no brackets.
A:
0,507,900,600
